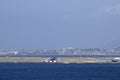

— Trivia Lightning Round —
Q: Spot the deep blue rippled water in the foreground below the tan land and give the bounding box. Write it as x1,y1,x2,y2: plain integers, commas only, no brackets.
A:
0,63,120,80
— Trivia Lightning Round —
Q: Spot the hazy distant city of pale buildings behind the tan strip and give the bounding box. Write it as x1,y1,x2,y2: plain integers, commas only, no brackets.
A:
0,48,120,56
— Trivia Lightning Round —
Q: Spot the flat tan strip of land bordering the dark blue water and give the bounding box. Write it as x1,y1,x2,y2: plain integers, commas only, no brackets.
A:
0,57,120,64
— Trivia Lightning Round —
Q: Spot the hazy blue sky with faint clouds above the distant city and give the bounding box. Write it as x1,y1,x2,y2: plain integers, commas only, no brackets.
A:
0,0,120,49
